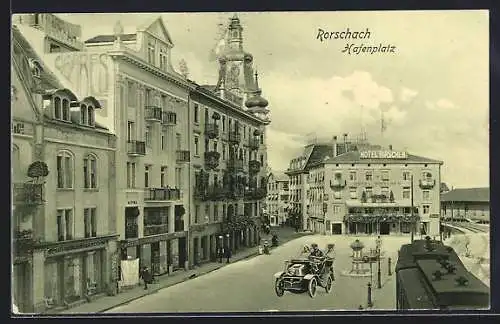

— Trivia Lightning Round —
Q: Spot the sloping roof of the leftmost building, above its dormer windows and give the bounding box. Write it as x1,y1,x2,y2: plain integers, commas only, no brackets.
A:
12,26,64,90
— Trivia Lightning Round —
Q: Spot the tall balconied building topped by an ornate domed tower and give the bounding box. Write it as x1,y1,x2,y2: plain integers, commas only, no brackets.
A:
189,16,269,264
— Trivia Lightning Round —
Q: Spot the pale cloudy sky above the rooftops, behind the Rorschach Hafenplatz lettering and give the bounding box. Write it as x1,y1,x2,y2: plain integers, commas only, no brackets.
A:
58,10,489,188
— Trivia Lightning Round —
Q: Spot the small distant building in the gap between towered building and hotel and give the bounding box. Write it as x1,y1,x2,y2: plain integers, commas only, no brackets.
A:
266,172,290,226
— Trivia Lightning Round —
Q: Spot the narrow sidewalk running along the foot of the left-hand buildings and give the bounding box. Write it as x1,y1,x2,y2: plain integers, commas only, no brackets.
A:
52,227,310,314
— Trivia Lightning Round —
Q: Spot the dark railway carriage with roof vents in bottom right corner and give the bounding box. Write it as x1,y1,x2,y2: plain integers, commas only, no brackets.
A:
396,237,490,310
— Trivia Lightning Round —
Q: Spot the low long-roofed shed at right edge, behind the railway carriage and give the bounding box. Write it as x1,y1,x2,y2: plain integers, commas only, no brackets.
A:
441,188,490,223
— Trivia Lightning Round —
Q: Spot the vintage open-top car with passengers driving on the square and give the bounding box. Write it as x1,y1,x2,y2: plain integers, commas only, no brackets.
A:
274,244,335,298
